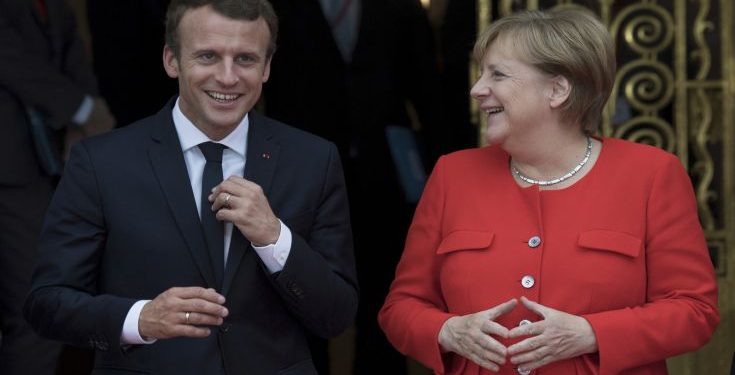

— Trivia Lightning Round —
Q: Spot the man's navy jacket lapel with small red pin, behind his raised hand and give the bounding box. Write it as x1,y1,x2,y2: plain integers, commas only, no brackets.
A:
222,111,281,296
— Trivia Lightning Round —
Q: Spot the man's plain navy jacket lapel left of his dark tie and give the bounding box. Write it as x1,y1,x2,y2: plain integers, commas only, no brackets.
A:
148,101,215,288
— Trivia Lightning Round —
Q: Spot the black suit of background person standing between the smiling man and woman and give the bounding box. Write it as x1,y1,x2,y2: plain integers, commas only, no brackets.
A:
264,0,466,374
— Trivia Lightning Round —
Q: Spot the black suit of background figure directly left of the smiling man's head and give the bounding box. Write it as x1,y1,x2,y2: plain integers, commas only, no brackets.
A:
87,0,176,126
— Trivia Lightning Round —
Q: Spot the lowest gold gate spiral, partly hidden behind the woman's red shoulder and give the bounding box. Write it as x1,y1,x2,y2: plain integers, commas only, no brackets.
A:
614,116,676,152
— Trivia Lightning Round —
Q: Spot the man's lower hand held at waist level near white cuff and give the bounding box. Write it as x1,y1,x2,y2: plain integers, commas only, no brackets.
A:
138,287,229,339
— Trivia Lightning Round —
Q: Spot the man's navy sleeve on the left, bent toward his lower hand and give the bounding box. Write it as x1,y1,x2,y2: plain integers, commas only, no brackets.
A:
24,141,135,350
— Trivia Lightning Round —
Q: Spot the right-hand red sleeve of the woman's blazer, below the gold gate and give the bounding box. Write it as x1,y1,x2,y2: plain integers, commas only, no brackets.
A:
584,156,719,375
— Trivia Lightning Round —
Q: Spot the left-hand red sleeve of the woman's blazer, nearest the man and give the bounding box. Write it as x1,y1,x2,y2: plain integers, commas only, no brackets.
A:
378,159,454,374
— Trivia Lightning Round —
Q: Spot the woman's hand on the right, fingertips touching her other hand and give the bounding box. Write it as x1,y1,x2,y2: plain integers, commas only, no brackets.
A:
508,297,597,370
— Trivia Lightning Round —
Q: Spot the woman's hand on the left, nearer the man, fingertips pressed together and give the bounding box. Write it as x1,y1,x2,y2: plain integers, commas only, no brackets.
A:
439,298,518,372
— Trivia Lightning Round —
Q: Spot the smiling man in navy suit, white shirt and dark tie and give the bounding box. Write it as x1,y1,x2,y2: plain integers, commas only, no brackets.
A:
25,0,357,374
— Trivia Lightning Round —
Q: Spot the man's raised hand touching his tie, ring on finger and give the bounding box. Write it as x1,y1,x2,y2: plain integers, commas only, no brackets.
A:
209,176,281,246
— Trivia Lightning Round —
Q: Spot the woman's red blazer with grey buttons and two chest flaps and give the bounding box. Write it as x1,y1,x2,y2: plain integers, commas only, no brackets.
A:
379,138,719,375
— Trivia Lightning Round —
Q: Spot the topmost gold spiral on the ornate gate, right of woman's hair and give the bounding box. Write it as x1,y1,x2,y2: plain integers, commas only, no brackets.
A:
611,3,674,54
